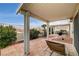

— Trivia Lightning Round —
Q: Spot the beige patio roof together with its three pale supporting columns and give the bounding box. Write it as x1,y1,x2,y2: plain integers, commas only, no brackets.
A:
17,3,79,55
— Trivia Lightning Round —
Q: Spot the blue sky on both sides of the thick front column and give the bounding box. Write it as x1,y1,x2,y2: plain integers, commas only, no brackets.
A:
0,3,43,26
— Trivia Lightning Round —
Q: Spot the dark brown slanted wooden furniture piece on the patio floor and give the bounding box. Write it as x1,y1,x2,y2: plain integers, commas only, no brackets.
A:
46,40,66,55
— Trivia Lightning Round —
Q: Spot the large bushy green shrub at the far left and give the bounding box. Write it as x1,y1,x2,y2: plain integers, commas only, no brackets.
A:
0,26,17,48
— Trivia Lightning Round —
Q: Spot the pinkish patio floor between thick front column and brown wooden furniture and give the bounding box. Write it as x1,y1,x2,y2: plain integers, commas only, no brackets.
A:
29,38,64,56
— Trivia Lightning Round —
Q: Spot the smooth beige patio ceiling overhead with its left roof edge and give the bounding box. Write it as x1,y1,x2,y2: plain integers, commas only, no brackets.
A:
17,3,78,22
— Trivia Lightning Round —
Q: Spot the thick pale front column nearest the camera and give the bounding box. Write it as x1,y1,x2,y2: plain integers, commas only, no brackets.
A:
24,12,30,55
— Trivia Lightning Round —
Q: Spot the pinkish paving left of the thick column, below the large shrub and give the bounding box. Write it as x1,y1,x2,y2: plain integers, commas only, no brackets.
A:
1,43,24,56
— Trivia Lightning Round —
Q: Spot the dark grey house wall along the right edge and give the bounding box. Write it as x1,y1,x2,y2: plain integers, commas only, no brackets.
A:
74,12,79,54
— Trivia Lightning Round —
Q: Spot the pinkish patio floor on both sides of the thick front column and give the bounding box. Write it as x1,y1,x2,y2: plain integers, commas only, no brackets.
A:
1,37,70,56
